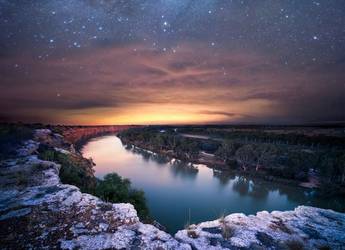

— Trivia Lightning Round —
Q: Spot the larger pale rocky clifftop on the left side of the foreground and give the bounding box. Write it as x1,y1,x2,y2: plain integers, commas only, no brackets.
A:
0,130,190,249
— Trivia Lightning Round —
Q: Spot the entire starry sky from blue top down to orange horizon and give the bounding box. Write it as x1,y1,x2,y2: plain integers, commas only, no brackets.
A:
0,0,345,124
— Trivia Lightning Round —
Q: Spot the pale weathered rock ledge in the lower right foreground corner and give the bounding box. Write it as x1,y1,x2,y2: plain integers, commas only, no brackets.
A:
175,206,345,249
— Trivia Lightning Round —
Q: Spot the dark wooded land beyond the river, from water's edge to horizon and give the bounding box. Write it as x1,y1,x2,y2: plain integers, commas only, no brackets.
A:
119,126,345,194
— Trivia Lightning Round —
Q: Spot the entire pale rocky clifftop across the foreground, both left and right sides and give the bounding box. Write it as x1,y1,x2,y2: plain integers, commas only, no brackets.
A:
0,130,345,249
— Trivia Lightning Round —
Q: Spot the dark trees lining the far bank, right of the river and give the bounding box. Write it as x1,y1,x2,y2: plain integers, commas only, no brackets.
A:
119,126,345,188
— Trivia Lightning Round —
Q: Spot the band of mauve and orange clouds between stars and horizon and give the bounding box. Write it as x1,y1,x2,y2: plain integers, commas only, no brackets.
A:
0,43,344,123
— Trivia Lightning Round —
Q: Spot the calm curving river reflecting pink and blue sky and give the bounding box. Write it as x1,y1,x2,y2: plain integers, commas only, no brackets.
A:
82,136,338,233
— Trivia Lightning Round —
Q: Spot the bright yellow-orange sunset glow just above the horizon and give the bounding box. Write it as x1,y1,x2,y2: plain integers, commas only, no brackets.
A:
53,100,270,125
